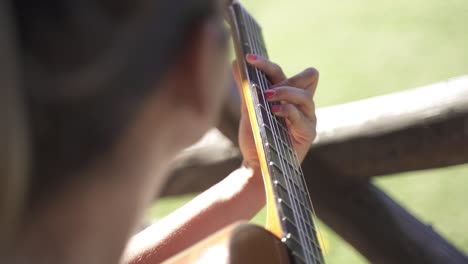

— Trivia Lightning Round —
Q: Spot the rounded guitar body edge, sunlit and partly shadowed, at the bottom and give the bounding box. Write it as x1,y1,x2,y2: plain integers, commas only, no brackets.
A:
165,223,291,264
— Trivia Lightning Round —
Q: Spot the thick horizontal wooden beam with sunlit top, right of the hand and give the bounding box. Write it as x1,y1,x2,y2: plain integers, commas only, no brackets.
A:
310,76,468,179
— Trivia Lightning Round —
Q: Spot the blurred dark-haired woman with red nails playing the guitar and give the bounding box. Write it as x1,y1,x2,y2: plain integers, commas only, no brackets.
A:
1,0,318,264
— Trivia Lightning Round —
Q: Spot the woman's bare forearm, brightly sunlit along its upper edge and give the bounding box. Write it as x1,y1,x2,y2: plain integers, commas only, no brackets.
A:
125,162,265,264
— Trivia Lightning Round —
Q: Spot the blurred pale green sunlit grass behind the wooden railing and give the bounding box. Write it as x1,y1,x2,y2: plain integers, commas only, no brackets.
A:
151,0,468,263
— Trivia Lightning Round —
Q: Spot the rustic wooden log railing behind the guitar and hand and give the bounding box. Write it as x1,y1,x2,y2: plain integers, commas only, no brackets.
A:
163,76,468,263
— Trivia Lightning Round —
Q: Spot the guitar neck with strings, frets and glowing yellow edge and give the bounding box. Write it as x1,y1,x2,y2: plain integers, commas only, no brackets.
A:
227,2,324,263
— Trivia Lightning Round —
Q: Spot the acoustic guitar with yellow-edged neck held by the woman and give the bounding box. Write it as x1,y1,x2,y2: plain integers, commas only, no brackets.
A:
168,0,324,264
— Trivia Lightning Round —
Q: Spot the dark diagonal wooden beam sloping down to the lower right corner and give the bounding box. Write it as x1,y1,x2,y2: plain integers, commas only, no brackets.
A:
304,160,468,264
